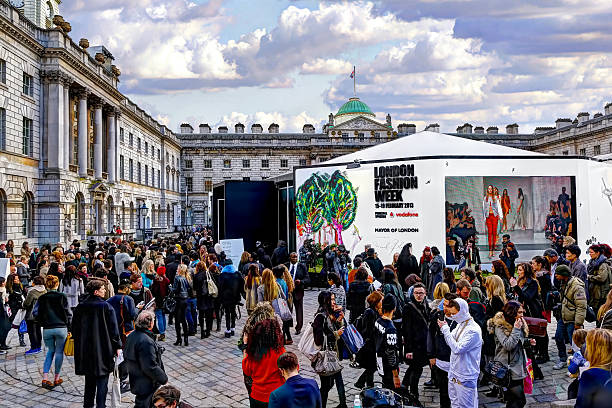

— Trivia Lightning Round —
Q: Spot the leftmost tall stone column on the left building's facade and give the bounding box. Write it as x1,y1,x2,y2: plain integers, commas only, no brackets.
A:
42,70,64,170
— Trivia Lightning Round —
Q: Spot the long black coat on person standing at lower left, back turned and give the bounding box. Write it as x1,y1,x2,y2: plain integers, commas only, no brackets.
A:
71,295,121,377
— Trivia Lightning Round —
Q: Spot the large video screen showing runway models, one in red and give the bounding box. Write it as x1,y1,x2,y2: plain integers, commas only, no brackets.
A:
445,176,577,265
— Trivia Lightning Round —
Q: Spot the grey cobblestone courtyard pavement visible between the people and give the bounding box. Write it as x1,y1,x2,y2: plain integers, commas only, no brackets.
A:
0,290,588,408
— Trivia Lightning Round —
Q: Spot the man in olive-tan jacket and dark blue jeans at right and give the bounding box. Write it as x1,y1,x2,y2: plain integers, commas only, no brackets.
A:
553,264,587,370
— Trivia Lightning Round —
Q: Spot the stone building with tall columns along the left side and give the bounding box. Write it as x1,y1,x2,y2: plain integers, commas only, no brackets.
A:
0,0,180,245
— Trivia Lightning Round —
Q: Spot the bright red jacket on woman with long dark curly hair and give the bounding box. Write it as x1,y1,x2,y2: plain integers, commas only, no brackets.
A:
242,347,285,402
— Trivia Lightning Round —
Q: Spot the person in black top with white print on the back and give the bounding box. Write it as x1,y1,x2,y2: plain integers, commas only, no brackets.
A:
374,293,402,390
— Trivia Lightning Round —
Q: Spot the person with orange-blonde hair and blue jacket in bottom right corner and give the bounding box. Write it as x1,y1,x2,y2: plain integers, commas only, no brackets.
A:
576,329,612,408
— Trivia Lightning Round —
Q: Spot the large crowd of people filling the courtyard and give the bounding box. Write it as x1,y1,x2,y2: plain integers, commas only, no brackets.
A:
0,233,612,408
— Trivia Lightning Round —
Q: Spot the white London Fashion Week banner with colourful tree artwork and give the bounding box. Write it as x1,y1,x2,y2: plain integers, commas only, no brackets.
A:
295,162,430,264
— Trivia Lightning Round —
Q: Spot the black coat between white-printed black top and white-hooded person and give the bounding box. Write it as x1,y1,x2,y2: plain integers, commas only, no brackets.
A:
402,297,431,366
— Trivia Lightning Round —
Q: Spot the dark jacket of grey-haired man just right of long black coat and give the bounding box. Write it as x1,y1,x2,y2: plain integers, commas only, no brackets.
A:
123,329,168,395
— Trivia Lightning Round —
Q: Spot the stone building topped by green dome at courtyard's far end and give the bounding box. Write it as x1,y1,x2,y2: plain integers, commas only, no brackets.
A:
177,98,397,224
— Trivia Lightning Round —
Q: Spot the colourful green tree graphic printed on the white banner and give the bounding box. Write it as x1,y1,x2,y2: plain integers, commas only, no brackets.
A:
295,170,357,244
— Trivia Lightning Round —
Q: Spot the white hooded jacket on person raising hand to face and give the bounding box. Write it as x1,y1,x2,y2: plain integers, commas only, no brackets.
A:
441,298,482,381
